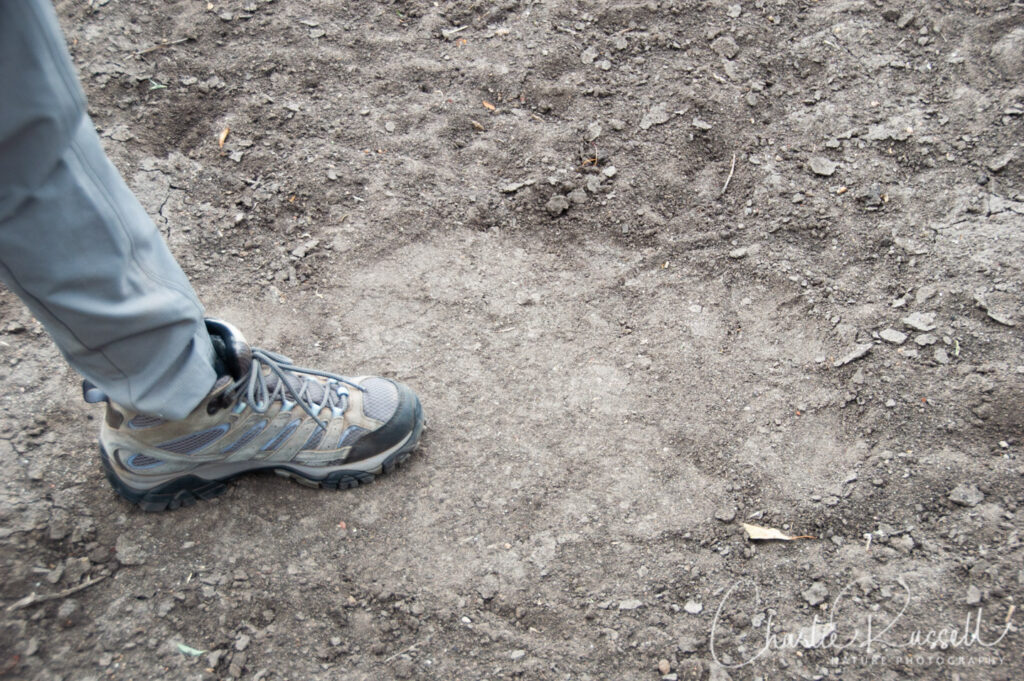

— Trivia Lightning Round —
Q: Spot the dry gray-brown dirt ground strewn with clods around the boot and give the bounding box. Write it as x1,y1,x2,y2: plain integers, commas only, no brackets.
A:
0,0,1024,681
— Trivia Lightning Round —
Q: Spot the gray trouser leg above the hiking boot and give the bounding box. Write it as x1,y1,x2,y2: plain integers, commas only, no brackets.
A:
0,0,216,419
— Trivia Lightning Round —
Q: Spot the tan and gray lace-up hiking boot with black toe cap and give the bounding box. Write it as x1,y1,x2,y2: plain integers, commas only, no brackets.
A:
83,320,423,511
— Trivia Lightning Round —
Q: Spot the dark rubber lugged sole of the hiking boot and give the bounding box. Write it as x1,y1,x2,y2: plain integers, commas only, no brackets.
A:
99,403,424,511
